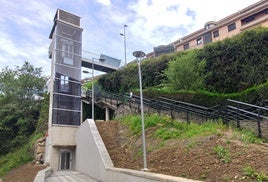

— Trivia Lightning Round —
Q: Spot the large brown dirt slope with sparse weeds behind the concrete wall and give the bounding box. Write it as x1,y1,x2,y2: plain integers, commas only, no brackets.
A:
96,121,268,182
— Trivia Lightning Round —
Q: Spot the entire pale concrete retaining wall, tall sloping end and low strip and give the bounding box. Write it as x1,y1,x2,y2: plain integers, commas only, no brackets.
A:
75,119,200,182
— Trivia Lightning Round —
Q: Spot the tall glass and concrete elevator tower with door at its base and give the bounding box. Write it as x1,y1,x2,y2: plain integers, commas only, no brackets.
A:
45,9,83,170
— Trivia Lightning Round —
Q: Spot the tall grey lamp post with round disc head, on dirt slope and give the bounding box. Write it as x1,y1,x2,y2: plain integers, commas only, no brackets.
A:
133,51,148,171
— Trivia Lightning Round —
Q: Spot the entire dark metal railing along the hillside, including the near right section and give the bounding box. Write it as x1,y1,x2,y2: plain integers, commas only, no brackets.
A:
86,90,268,137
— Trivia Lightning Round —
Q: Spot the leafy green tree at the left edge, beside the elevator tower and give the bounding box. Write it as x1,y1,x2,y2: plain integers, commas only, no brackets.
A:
0,61,46,154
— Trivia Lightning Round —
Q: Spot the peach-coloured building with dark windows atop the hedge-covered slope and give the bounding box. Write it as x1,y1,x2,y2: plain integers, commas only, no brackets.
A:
171,0,268,52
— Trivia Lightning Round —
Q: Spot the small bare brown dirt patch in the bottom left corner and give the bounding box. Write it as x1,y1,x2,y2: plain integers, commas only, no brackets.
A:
3,162,45,182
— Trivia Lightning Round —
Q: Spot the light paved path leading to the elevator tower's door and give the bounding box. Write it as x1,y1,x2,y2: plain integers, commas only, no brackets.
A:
45,170,97,182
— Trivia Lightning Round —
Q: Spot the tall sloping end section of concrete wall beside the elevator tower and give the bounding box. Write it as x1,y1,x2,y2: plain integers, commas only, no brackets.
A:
75,119,113,181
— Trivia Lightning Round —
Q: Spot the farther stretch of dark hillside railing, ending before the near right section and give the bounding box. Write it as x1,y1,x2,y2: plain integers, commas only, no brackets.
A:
86,90,222,122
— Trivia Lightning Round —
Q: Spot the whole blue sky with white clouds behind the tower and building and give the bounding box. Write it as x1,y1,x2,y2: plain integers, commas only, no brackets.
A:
0,0,259,76
